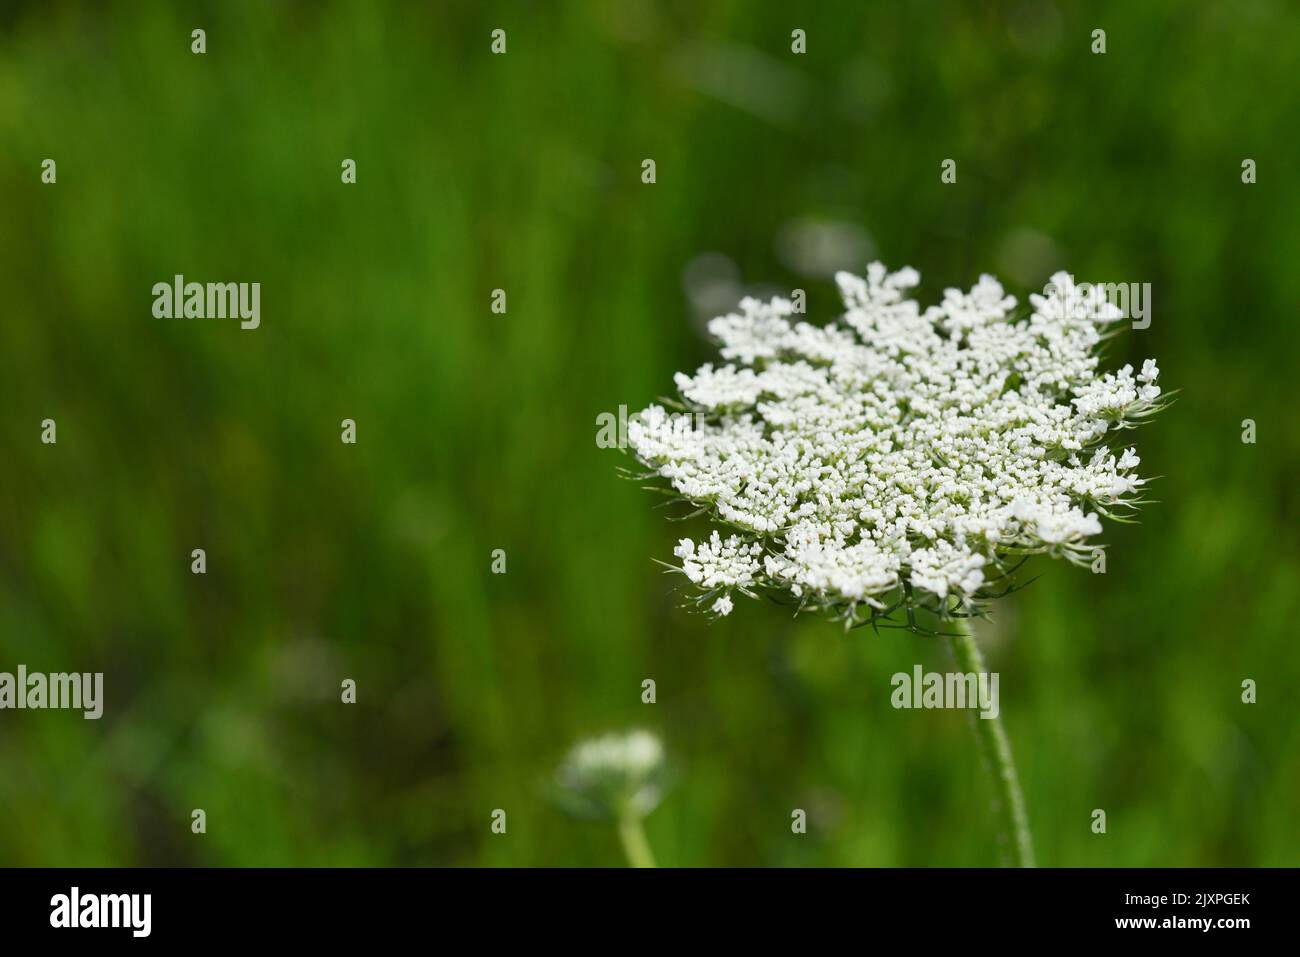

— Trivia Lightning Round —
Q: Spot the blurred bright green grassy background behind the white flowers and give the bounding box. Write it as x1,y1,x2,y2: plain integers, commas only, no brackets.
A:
0,0,1300,865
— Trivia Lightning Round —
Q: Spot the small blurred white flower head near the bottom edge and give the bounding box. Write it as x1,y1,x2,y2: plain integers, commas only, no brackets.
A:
555,731,664,818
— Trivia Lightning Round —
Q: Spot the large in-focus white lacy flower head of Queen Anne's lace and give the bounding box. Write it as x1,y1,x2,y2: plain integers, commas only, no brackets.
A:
628,263,1161,624
